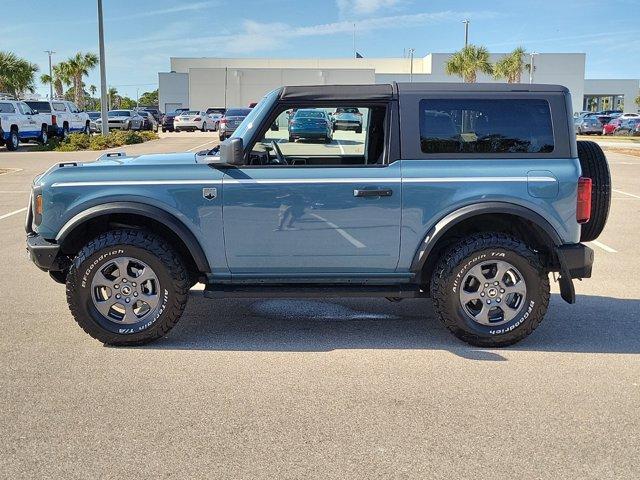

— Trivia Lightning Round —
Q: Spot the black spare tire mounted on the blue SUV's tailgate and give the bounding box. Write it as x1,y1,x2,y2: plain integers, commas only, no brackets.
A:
578,141,611,242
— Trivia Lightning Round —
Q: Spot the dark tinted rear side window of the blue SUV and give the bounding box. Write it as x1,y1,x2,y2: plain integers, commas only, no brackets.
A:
419,98,554,154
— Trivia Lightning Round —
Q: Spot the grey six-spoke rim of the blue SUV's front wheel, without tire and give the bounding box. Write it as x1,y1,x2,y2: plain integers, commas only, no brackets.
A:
91,257,160,325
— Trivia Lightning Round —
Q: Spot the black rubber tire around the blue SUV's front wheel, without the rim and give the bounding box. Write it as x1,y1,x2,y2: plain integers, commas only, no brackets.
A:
67,229,189,346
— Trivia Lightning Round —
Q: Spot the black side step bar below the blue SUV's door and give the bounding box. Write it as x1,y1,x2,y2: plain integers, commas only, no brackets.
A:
203,284,429,298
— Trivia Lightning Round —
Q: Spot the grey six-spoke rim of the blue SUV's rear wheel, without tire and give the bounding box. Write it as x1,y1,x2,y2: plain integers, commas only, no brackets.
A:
460,260,527,326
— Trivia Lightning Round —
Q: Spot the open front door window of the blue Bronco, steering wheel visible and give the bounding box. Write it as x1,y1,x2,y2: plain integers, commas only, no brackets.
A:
250,105,386,167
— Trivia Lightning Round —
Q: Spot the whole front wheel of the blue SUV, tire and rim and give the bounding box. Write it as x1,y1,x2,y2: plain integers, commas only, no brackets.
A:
67,230,189,345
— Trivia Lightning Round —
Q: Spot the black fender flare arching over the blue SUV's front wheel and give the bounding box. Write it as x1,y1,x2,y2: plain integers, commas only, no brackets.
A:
56,202,211,273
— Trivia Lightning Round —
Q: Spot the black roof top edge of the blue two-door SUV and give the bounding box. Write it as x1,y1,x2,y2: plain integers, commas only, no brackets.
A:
280,82,569,101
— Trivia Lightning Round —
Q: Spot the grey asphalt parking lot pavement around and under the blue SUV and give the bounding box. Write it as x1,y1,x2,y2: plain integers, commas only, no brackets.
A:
0,132,640,479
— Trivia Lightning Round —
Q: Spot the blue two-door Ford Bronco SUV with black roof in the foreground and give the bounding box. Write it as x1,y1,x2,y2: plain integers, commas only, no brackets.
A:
26,83,611,347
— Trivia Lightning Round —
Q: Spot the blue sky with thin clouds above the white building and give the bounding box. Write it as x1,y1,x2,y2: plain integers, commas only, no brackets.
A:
0,0,640,97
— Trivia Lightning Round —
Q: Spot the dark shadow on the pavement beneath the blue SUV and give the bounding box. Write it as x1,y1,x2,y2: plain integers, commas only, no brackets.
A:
134,295,640,361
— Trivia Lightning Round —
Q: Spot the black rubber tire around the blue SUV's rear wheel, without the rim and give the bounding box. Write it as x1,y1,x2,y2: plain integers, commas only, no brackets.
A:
431,233,549,348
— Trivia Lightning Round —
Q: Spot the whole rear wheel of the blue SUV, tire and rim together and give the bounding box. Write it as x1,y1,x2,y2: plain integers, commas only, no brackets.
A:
431,233,549,347
